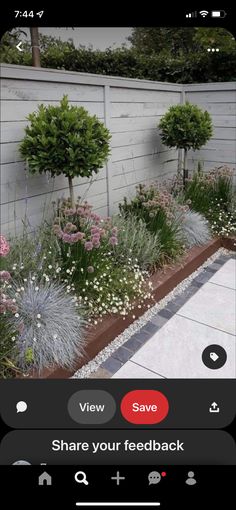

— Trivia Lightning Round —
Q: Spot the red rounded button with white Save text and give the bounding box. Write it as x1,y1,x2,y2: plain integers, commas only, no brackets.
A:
120,390,169,425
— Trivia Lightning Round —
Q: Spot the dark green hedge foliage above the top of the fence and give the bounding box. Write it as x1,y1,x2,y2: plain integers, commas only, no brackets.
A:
1,29,236,83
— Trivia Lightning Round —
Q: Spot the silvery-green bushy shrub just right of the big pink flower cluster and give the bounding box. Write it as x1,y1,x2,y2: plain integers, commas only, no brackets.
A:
112,215,161,269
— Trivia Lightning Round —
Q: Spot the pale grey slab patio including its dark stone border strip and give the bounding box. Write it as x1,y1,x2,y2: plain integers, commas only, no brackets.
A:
84,252,236,379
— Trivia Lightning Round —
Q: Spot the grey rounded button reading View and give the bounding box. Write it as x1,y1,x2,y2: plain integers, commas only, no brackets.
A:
68,390,116,425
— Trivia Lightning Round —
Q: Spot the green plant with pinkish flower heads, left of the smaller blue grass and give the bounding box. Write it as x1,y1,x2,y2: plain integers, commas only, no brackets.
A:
119,184,183,263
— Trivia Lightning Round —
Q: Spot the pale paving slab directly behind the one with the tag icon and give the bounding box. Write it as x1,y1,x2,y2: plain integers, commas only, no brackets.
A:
177,282,236,335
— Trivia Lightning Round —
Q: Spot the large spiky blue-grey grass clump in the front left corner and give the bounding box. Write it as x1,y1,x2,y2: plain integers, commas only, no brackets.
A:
9,277,84,371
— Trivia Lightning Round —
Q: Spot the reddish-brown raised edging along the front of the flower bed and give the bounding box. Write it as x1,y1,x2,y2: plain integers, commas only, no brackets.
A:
29,238,236,379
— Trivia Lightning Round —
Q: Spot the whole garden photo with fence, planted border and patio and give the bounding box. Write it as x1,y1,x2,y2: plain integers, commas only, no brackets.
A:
0,27,236,379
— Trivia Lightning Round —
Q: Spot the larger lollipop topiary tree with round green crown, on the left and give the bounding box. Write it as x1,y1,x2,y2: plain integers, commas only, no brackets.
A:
20,96,111,207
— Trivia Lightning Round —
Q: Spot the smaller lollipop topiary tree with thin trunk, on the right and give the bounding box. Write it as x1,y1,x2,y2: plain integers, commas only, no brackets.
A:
159,103,213,187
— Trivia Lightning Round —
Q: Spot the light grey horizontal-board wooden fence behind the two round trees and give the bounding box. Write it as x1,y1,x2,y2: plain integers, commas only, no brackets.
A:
1,64,235,237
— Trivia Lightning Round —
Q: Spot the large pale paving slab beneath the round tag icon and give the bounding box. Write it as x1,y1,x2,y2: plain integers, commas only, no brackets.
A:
130,315,235,379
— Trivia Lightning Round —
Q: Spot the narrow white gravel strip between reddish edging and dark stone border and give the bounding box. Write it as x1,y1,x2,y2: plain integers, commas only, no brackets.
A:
71,248,230,379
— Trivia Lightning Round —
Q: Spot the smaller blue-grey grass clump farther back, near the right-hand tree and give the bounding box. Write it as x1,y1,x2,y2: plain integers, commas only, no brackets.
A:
177,210,212,248
